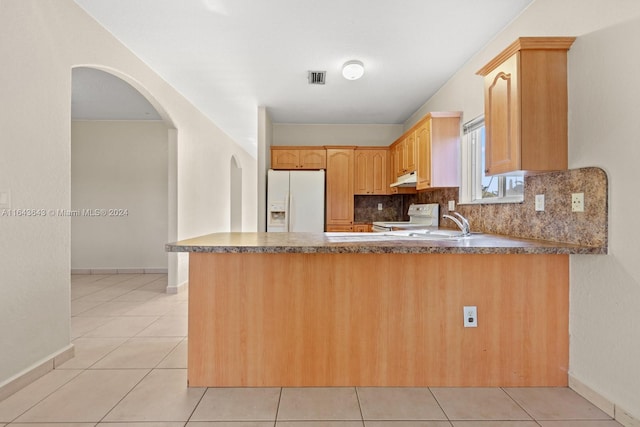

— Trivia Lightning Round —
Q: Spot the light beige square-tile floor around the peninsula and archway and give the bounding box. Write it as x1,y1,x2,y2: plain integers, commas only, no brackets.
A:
0,274,620,427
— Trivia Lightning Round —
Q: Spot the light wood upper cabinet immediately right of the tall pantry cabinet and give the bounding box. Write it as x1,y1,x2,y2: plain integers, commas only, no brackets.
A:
353,147,390,194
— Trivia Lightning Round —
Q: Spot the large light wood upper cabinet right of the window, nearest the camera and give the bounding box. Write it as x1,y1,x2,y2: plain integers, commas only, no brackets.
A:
477,37,575,175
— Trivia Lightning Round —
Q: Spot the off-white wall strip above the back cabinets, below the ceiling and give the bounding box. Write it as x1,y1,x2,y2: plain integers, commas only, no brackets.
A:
273,123,403,146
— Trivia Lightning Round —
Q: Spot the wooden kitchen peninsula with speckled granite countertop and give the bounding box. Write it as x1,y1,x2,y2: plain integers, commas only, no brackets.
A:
166,233,606,387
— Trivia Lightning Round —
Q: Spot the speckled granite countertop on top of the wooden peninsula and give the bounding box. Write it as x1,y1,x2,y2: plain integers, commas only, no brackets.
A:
165,233,607,254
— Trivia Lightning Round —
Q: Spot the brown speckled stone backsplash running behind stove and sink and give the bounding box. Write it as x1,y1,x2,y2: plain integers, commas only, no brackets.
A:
355,167,608,247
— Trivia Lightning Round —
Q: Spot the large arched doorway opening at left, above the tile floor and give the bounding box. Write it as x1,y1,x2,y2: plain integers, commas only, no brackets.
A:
71,66,178,291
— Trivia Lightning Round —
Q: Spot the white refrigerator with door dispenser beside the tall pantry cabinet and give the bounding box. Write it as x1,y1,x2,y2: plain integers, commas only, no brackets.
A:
267,169,324,232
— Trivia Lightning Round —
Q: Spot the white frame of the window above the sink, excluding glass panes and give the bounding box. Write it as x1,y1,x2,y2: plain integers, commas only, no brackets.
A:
458,116,524,204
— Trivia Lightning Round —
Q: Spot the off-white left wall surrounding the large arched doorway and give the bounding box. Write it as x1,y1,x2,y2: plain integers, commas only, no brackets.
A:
0,0,257,386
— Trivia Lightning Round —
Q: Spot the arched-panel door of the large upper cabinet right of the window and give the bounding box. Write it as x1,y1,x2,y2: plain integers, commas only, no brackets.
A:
484,53,521,175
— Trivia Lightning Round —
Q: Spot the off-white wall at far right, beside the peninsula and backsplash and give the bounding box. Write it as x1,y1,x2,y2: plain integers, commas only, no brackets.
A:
569,18,640,419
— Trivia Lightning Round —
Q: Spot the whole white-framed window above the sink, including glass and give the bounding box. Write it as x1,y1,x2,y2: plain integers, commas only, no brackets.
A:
460,116,524,203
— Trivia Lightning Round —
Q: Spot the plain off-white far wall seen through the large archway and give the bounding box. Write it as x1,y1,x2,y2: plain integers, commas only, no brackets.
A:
71,121,169,269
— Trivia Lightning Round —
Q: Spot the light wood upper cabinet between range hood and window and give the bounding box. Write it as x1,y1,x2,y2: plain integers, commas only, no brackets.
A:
410,112,460,190
